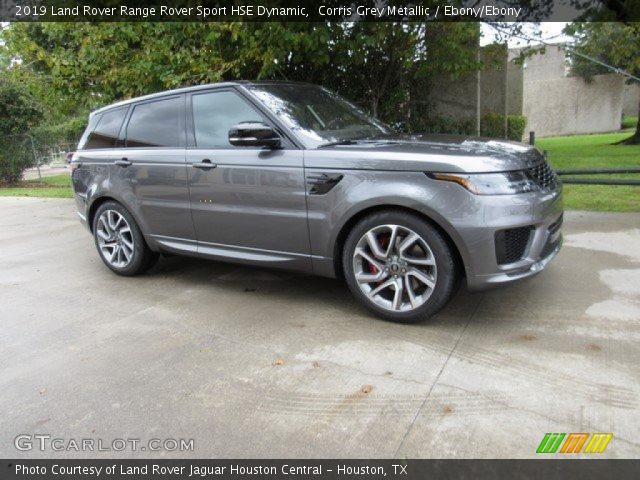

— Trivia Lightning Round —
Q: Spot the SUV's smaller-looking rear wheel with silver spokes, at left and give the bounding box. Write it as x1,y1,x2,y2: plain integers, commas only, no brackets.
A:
93,201,159,277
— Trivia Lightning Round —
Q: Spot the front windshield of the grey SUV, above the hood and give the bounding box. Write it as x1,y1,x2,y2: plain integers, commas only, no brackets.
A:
248,84,390,147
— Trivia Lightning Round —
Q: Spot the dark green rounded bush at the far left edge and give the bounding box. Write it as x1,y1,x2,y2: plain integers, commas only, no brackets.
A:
0,75,41,184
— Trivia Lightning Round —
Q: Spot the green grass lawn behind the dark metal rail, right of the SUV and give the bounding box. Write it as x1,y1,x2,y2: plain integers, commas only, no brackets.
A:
537,131,640,212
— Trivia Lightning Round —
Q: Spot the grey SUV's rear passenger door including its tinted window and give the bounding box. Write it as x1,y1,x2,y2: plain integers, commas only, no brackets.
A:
119,95,195,244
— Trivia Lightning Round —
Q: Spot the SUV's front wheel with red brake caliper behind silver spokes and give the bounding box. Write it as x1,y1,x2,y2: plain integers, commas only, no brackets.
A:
342,210,458,323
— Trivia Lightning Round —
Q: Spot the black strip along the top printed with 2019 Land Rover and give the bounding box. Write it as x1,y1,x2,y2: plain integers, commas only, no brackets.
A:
0,0,640,22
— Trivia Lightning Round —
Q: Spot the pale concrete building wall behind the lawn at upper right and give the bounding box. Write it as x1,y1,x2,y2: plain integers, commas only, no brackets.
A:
430,44,628,136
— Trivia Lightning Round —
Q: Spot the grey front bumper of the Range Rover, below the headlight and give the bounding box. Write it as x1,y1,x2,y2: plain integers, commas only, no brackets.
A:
463,184,563,290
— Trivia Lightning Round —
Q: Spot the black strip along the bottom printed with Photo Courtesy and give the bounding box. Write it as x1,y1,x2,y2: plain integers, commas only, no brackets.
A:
0,457,640,480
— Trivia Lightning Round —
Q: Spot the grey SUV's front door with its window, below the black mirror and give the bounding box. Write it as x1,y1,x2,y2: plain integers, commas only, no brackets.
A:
187,88,311,270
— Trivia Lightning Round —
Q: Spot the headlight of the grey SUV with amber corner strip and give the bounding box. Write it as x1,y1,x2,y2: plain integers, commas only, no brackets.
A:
428,171,539,195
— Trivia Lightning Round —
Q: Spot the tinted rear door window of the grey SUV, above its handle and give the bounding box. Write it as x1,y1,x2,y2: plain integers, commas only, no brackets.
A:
127,97,184,148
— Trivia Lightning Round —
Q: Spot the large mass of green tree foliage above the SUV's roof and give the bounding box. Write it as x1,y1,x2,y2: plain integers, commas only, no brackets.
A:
2,22,479,128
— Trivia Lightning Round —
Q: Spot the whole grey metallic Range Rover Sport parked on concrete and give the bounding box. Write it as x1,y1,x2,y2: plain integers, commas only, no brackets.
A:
72,82,562,321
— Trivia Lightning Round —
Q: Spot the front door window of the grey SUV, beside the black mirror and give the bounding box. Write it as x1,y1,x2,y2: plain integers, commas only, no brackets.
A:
191,90,266,148
